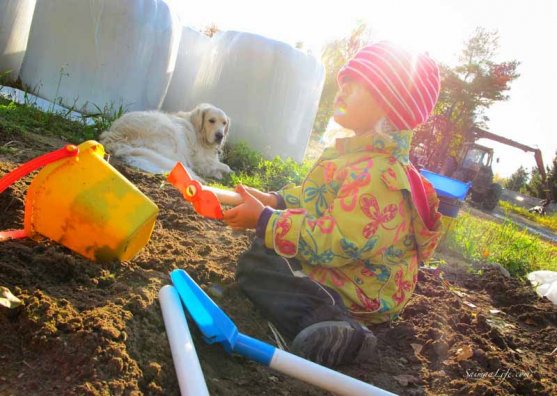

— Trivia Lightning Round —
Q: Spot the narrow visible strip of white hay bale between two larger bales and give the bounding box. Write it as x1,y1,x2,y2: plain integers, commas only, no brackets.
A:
162,26,212,112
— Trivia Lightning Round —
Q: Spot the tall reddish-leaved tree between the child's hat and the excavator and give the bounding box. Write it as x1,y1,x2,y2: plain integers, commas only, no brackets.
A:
413,28,519,171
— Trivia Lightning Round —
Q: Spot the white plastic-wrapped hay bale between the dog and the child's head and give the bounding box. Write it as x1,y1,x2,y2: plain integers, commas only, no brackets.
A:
192,31,325,161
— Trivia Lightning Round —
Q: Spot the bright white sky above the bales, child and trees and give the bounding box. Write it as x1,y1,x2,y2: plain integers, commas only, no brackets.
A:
174,0,557,177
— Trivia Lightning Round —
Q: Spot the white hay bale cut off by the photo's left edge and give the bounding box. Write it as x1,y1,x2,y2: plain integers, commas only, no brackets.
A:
0,0,35,80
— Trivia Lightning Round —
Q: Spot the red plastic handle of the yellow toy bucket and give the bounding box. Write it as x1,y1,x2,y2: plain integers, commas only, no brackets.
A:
0,144,79,242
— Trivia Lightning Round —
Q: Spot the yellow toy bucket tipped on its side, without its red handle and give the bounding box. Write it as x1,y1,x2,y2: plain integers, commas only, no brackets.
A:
25,140,158,261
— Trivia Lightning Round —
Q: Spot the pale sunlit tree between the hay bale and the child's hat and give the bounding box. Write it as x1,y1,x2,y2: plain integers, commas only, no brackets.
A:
313,22,371,135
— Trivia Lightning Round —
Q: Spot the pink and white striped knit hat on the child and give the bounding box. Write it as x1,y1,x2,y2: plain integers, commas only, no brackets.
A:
337,41,440,130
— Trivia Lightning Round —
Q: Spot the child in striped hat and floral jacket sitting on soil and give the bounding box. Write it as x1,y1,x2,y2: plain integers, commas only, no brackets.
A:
224,42,441,367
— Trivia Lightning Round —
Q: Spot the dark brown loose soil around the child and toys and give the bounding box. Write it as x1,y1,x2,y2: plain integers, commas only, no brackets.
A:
0,131,557,395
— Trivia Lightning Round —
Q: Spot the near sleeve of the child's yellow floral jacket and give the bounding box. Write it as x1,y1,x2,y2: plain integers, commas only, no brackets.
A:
265,162,410,267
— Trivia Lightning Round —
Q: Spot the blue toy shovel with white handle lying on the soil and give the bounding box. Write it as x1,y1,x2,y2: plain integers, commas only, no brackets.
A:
170,270,393,396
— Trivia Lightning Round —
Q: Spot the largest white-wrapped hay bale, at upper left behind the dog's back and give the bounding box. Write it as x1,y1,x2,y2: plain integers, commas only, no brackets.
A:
21,0,181,112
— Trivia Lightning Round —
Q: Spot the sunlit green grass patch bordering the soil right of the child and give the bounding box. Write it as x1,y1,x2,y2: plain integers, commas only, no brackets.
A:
443,213,557,277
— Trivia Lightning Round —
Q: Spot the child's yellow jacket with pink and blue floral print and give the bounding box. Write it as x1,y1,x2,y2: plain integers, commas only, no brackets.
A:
264,131,441,323
